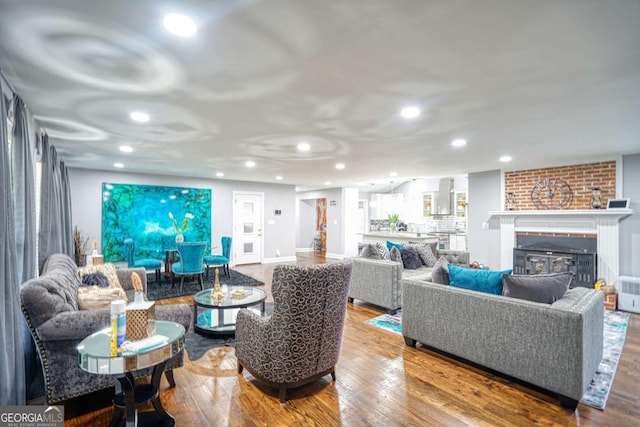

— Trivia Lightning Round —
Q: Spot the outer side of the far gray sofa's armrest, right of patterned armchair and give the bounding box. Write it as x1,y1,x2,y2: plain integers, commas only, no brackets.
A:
349,257,403,310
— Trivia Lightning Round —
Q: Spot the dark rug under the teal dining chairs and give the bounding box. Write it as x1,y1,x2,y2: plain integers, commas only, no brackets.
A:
147,270,264,301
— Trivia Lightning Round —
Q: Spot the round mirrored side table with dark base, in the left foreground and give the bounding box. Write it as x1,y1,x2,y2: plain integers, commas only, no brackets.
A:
78,320,185,427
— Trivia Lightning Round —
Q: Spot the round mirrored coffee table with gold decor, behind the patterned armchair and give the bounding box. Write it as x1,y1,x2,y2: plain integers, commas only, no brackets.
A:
193,285,267,336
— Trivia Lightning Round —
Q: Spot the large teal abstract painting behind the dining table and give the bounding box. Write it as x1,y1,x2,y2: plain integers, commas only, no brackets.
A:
102,182,211,262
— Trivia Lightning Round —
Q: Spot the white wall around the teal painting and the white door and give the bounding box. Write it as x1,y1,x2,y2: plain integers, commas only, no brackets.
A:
69,168,296,258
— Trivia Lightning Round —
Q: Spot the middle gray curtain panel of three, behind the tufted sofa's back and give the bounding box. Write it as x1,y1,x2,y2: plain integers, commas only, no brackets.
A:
10,95,39,400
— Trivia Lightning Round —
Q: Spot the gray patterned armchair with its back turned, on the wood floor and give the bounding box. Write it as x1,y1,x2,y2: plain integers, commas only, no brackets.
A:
236,262,352,403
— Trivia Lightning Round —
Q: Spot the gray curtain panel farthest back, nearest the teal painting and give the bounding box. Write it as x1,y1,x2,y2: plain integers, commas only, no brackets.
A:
38,134,73,268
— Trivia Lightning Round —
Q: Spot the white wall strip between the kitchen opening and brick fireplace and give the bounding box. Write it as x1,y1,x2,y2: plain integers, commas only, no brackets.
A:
467,170,502,270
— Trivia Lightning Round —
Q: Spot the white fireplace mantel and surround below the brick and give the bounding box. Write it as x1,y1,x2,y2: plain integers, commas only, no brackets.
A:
489,209,633,283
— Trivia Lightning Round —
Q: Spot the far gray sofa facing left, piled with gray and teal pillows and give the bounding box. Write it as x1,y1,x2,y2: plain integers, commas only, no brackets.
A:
349,250,469,314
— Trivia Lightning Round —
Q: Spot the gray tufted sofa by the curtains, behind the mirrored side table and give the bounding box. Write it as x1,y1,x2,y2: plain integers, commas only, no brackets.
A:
20,254,191,404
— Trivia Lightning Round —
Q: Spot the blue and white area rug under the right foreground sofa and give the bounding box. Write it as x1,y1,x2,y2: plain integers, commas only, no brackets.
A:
366,310,629,409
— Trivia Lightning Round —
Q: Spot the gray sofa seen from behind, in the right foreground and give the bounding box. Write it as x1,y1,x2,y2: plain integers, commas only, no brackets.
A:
402,276,604,409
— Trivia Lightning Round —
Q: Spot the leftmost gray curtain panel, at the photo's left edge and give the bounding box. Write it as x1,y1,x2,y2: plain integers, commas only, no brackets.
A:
0,76,26,405
